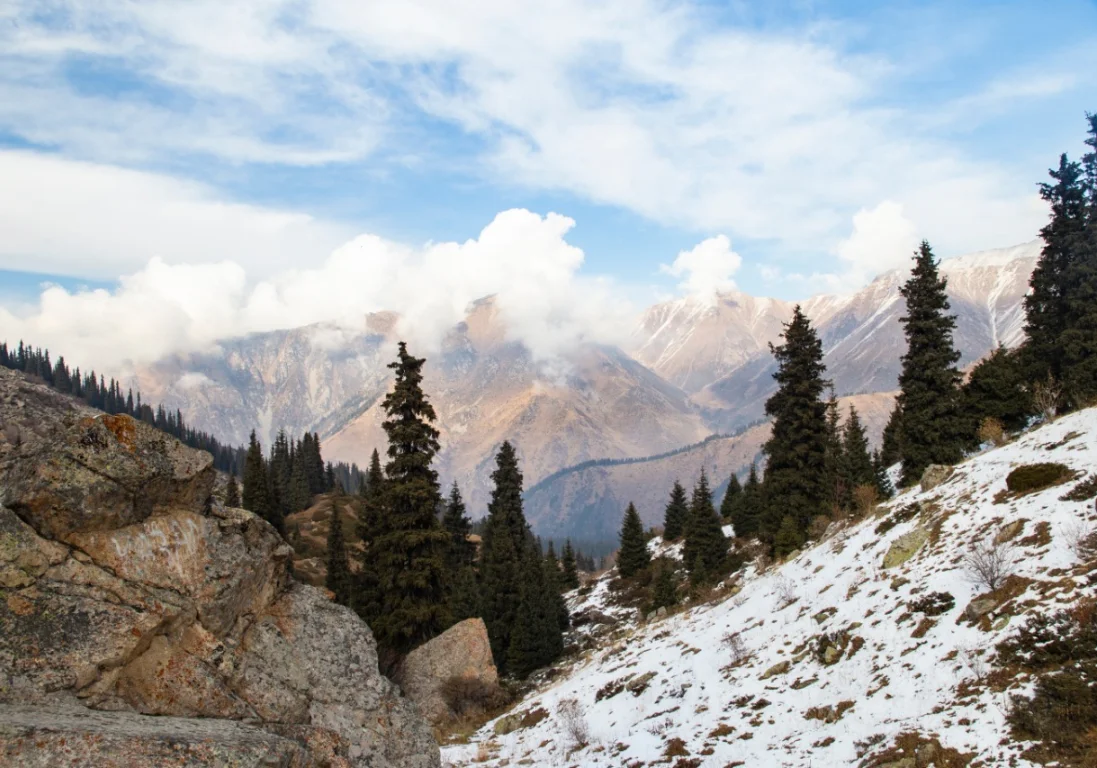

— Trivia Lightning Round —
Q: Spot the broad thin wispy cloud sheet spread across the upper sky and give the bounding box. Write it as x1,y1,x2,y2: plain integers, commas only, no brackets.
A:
0,0,1061,261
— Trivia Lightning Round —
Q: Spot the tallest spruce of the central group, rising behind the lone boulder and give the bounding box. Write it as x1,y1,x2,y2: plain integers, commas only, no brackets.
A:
368,341,450,654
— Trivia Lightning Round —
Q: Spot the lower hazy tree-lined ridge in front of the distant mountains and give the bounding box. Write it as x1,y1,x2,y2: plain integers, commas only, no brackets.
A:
525,393,894,541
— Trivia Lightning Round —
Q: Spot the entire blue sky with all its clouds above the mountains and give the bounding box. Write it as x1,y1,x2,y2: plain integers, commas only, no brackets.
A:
0,0,1097,364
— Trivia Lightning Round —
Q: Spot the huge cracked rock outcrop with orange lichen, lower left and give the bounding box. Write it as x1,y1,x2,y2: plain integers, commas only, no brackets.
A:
0,370,439,768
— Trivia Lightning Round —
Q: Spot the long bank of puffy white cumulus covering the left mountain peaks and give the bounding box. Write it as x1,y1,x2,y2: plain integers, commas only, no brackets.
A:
0,210,632,370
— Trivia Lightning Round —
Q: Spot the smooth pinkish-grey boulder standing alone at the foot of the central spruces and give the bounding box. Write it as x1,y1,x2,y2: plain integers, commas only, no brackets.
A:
396,619,499,725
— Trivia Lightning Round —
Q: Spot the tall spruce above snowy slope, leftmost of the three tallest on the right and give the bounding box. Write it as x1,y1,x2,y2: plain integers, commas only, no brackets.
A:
759,306,828,542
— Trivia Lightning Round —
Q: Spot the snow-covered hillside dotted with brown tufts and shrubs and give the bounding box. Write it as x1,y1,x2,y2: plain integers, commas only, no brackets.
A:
443,409,1097,768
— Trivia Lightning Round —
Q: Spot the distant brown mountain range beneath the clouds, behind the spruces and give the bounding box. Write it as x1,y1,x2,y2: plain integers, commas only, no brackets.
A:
126,241,1040,537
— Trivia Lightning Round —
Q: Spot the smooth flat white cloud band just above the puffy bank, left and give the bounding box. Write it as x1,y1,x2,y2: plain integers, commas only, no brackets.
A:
0,150,352,280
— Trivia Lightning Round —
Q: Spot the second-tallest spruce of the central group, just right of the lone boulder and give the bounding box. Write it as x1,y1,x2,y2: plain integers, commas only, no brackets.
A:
480,442,530,668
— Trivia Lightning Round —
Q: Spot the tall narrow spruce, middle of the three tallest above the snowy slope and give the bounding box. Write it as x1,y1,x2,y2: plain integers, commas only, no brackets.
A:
898,240,972,485
